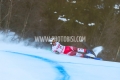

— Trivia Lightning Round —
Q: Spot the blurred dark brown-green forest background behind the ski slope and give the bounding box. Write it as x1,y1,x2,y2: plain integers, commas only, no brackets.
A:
0,0,120,61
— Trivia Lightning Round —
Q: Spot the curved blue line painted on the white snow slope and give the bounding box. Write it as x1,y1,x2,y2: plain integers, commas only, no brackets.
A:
5,51,70,80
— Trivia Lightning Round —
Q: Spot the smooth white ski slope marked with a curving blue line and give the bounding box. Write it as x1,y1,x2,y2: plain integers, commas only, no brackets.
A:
0,32,120,80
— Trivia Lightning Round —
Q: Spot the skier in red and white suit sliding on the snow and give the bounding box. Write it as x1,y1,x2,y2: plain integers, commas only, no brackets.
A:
48,38,94,58
